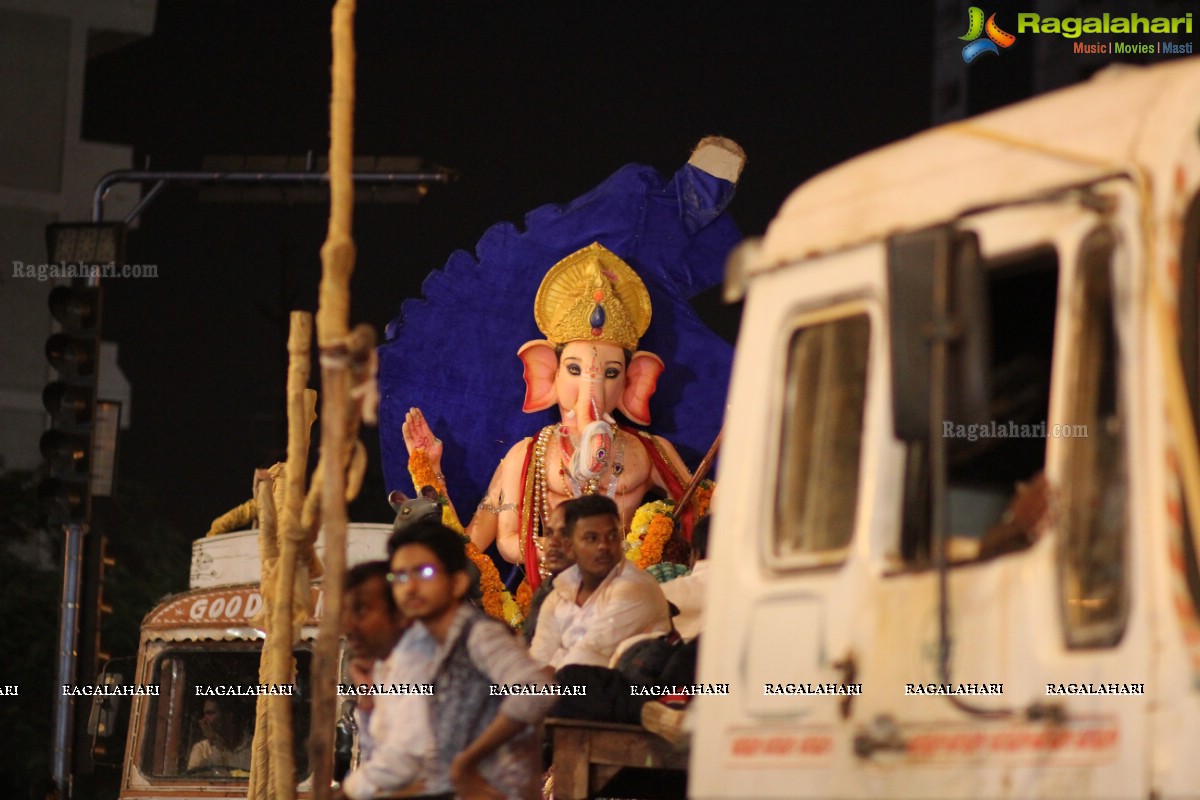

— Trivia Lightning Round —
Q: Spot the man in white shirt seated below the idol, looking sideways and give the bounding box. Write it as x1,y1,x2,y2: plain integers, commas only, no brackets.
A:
529,494,671,669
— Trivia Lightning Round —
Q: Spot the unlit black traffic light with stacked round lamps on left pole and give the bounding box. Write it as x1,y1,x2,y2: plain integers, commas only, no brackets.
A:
38,281,100,524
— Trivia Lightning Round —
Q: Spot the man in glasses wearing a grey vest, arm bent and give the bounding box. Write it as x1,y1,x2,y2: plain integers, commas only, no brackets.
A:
388,522,554,800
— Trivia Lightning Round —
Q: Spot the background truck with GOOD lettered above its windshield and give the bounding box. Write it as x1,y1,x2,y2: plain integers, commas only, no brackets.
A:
99,523,392,800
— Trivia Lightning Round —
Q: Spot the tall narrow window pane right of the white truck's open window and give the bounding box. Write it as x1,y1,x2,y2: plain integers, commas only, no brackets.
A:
1058,231,1128,648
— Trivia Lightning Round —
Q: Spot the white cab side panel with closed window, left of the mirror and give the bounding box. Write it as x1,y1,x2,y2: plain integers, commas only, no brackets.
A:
690,245,896,798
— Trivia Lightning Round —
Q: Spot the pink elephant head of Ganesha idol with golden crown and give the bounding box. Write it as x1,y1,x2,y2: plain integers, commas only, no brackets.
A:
517,243,662,482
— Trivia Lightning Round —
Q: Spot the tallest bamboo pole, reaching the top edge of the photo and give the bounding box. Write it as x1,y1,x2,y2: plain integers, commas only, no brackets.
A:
310,0,354,800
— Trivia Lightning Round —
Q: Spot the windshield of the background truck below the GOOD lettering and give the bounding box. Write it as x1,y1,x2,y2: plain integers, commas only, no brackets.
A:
140,643,312,781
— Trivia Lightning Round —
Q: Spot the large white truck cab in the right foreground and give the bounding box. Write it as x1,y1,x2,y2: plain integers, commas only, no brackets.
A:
689,59,1200,799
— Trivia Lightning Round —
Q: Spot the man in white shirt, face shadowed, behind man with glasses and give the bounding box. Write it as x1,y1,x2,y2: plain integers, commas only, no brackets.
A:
342,561,433,800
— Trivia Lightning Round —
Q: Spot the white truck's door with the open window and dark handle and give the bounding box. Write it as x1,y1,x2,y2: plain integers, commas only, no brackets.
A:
853,199,1153,798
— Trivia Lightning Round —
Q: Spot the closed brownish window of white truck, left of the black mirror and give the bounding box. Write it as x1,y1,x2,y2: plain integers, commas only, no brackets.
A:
773,313,870,566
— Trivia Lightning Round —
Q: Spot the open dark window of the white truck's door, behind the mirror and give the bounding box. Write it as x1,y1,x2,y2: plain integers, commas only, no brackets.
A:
893,248,1058,567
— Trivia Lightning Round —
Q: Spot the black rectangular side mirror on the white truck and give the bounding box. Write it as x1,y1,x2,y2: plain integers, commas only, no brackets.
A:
888,227,991,441
